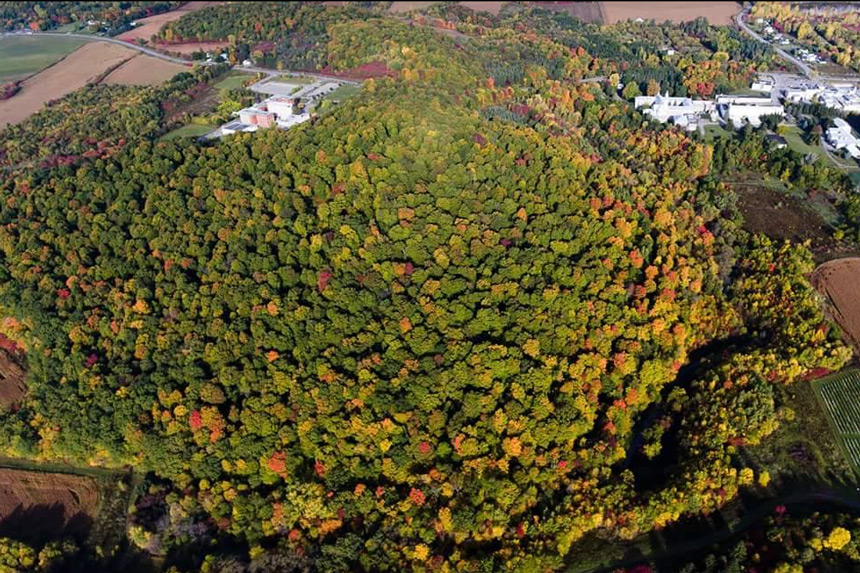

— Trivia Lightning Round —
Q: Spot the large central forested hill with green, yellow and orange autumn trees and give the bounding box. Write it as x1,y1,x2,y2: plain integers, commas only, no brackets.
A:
0,2,850,571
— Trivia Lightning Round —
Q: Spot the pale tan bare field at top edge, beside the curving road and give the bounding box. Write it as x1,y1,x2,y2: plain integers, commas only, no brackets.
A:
601,2,741,25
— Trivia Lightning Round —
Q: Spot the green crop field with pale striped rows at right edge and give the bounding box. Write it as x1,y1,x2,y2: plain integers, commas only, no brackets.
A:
813,370,860,472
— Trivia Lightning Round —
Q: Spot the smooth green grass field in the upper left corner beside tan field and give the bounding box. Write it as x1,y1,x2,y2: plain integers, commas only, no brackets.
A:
0,36,86,83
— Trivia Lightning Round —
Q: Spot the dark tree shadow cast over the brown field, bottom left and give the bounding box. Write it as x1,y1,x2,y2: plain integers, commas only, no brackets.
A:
0,503,93,546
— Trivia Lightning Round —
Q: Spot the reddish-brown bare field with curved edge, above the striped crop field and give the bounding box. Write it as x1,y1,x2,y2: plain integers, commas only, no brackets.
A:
812,257,860,350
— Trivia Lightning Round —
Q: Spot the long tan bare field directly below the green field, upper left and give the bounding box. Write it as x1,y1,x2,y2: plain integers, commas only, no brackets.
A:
0,42,136,128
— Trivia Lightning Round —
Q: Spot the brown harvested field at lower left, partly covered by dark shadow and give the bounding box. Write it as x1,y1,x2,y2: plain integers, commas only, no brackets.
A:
0,468,99,542
